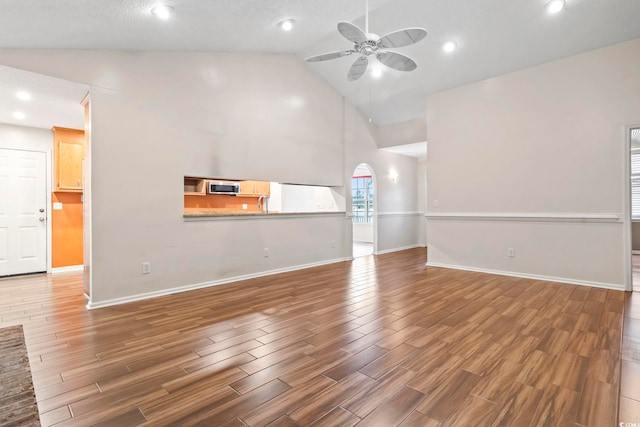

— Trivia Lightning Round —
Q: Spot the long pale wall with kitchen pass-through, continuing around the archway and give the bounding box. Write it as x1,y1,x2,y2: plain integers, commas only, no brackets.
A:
0,50,417,306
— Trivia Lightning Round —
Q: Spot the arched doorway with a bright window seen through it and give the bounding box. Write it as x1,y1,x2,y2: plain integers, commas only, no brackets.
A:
351,163,378,258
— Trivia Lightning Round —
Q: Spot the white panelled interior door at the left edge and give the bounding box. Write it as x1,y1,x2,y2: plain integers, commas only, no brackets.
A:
0,148,47,276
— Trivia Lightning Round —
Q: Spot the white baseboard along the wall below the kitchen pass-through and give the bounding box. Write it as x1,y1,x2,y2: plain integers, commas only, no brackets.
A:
86,257,353,310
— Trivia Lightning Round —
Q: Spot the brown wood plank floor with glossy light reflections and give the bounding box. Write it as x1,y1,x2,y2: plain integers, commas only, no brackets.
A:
0,249,624,427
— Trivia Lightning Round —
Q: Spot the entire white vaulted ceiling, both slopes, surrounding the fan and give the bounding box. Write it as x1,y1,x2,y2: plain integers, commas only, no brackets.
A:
0,0,640,137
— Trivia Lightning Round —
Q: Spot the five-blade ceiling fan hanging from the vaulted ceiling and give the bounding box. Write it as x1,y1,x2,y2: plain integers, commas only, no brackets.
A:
305,0,427,81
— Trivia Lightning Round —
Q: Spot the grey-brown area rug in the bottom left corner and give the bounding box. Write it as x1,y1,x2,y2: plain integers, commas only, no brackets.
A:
0,325,40,427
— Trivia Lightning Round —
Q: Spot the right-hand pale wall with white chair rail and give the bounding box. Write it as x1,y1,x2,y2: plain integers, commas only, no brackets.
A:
427,39,640,289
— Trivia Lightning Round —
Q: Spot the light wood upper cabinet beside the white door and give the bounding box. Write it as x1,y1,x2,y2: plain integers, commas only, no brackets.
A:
52,126,84,192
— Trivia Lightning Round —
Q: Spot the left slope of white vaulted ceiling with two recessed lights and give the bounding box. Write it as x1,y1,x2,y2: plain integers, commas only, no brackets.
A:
0,0,389,53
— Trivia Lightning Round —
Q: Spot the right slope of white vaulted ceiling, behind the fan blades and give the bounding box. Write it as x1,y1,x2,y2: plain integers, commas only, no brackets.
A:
300,0,640,125
